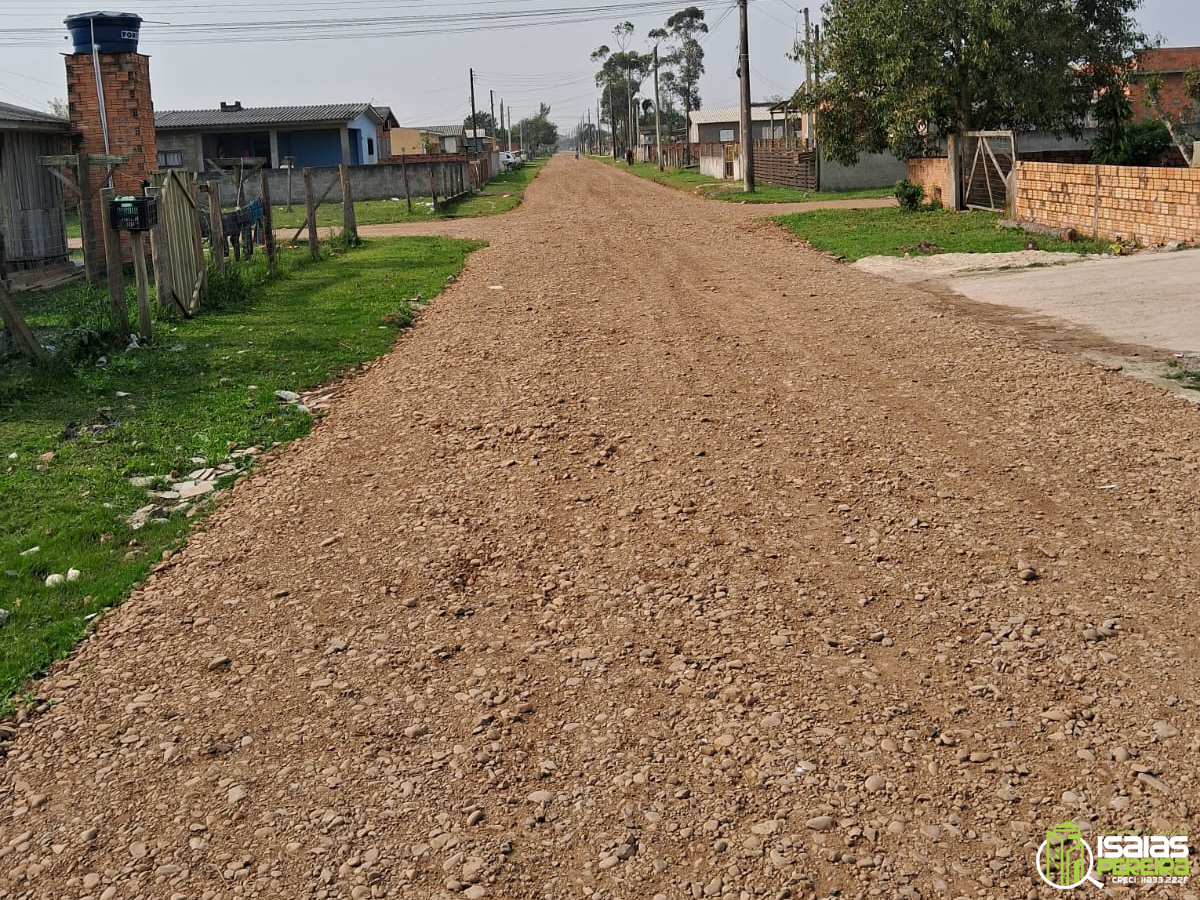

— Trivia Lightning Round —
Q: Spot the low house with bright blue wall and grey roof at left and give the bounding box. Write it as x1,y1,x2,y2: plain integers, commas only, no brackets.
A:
155,103,395,172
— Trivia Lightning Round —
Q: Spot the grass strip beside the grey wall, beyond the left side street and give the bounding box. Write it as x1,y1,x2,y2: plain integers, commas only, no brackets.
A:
272,160,545,228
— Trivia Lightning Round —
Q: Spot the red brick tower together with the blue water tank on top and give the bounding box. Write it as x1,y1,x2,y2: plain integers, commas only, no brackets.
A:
66,13,158,266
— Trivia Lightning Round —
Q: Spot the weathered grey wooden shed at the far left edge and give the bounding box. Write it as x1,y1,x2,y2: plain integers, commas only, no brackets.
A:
0,103,71,272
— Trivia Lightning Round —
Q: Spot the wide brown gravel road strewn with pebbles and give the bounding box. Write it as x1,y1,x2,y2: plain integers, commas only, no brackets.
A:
0,157,1200,900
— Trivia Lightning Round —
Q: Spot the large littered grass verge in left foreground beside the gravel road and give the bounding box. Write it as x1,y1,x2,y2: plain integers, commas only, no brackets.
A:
0,238,479,712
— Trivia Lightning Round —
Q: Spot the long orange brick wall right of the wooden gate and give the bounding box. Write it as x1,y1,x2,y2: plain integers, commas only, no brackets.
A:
1016,161,1200,246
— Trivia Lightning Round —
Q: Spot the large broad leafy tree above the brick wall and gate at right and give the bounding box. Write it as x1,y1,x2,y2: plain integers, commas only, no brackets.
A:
794,0,1146,163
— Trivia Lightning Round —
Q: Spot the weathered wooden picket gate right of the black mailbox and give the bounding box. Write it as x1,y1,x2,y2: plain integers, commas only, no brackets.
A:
155,169,208,316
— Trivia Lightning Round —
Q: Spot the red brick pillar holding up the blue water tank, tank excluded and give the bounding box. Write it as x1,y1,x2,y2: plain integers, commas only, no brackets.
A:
66,53,158,264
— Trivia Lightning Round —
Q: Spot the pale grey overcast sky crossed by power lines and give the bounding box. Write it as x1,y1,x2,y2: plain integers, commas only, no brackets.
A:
0,0,1200,130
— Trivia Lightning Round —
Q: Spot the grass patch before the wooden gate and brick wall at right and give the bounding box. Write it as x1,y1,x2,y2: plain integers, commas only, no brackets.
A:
775,208,1108,263
